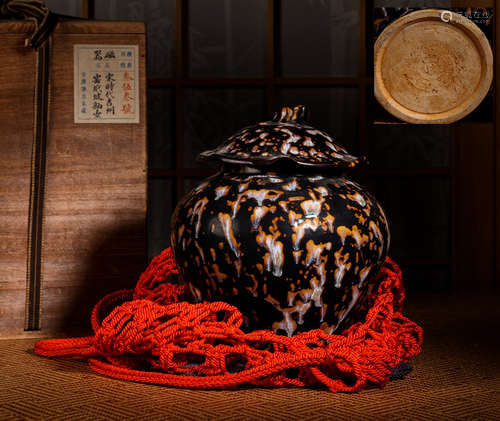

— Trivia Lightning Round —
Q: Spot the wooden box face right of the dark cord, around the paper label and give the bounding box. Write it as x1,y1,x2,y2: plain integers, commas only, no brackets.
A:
42,21,146,332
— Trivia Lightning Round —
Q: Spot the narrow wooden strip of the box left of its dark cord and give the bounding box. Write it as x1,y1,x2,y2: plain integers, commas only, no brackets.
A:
0,32,36,336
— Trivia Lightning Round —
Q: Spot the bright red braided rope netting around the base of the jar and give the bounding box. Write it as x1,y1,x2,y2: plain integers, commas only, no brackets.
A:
35,249,422,392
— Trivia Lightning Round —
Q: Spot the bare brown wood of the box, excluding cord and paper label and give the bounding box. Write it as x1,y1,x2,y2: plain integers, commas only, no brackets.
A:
0,22,146,337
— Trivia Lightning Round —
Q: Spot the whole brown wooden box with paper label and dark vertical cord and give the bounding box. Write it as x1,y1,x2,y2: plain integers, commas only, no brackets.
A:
0,21,146,338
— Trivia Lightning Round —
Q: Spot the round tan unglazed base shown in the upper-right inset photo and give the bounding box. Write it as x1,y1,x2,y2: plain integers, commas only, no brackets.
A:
374,10,493,124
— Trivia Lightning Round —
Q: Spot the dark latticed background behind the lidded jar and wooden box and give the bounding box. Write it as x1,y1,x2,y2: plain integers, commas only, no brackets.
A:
46,0,496,292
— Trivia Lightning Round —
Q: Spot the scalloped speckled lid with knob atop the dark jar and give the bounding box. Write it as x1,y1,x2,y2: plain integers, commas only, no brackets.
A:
198,105,360,167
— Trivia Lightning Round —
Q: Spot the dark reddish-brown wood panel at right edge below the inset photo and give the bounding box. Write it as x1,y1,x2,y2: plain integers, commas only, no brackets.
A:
452,122,495,291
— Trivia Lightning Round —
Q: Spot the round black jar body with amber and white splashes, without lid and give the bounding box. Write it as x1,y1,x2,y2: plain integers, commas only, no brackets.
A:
172,173,389,335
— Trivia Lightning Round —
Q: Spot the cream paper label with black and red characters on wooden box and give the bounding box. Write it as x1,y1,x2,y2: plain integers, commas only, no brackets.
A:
74,44,139,123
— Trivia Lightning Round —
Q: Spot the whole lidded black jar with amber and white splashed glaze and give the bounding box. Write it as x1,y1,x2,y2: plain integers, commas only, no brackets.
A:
171,106,390,336
